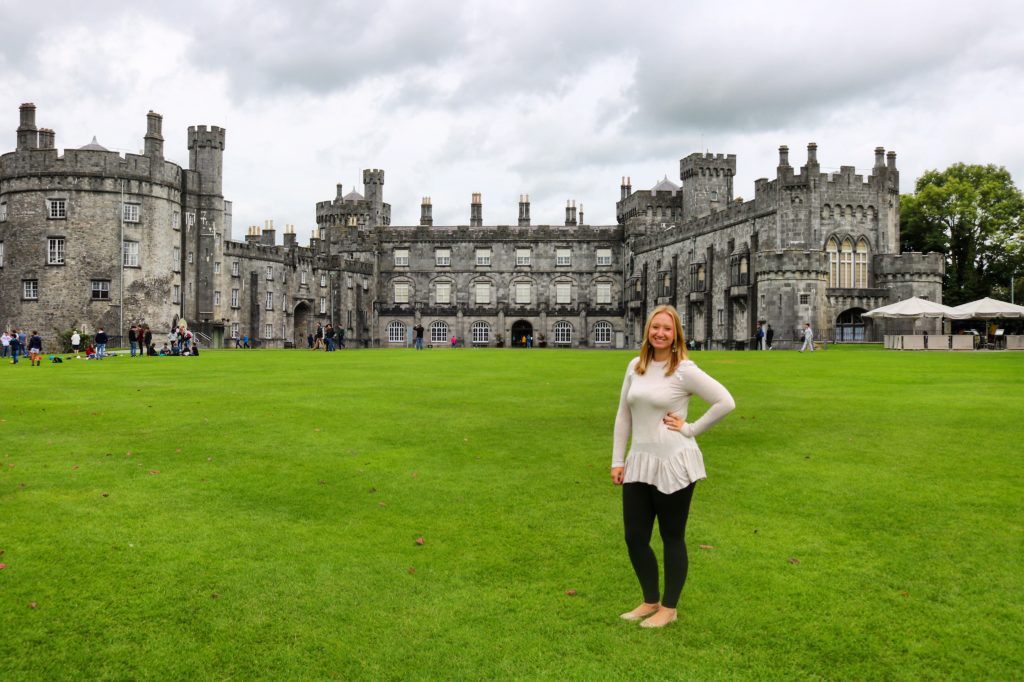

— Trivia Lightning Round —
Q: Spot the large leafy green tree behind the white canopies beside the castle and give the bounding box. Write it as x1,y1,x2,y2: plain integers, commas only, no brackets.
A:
900,164,1024,305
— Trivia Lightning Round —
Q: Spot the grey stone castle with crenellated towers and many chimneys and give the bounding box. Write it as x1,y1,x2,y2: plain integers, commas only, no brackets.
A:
0,103,943,348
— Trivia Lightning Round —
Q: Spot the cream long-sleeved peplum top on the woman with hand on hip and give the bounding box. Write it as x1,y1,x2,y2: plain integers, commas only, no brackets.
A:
611,357,736,495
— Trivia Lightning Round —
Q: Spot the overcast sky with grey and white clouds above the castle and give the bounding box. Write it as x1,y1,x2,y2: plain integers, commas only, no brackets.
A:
0,0,1024,243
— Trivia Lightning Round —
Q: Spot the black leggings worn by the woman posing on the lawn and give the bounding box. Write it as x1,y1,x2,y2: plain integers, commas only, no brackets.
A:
623,482,696,608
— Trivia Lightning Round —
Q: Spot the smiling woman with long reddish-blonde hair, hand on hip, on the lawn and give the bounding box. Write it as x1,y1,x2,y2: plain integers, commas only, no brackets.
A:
611,305,736,628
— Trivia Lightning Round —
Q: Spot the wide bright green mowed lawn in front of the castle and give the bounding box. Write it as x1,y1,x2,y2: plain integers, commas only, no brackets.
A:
0,348,1024,680
